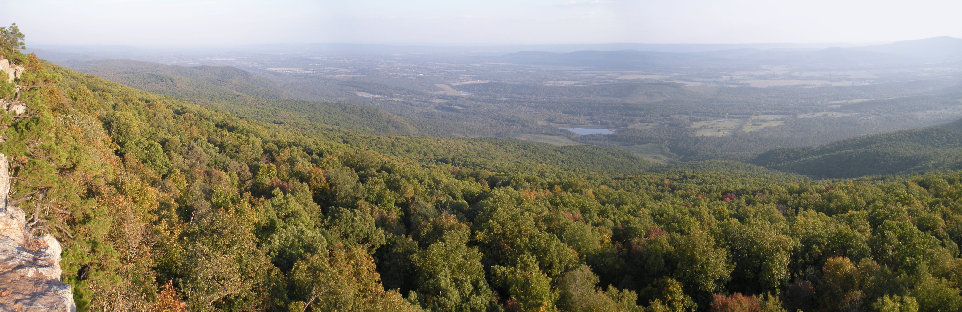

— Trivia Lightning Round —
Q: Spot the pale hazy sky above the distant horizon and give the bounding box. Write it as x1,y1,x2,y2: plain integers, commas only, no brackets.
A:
0,0,962,46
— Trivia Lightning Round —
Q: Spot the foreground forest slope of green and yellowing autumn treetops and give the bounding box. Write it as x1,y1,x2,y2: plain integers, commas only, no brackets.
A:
9,37,962,311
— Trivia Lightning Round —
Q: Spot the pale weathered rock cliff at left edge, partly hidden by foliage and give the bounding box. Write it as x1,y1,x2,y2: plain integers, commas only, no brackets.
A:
0,59,77,312
